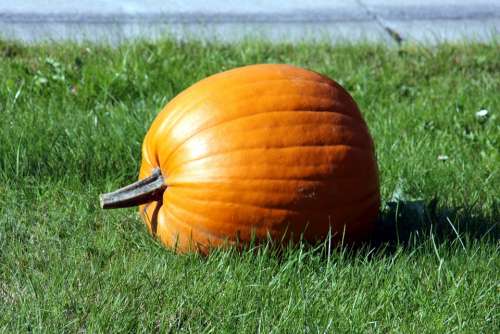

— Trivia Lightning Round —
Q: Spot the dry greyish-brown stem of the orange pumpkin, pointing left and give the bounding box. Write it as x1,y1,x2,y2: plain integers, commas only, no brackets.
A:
99,168,167,209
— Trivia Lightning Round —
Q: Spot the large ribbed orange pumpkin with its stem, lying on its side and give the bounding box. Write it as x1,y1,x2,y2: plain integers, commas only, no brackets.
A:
101,64,380,253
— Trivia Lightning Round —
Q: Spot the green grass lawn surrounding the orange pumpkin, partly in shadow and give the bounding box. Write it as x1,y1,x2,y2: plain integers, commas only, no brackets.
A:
0,40,500,333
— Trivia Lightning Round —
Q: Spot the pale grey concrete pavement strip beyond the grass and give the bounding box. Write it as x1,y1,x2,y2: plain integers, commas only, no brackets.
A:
0,0,500,43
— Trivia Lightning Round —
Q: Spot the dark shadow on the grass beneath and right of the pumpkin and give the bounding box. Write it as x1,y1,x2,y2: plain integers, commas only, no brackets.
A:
296,199,500,261
